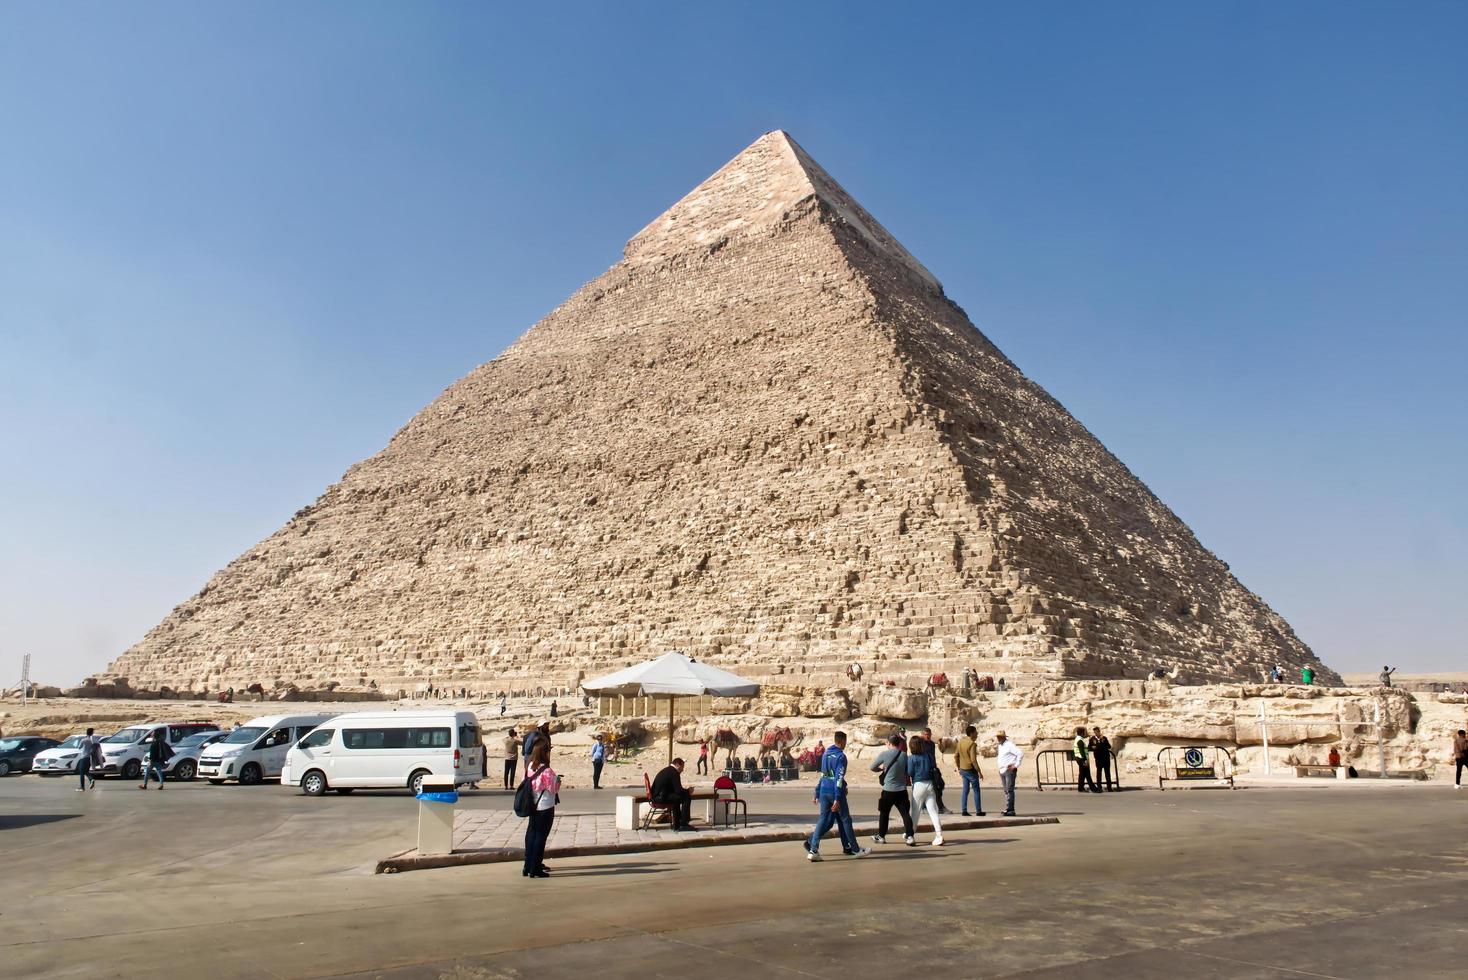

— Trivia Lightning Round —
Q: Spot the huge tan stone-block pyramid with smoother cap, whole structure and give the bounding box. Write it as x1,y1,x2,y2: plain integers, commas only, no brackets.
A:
110,132,1339,690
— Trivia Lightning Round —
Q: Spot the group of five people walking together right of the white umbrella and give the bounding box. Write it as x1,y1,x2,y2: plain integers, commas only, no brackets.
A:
804,725,1025,861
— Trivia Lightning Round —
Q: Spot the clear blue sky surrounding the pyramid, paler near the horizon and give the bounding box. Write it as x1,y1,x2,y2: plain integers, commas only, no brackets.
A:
0,0,1468,684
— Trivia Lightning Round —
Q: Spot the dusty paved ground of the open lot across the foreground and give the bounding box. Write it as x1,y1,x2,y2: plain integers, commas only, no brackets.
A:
0,776,1468,980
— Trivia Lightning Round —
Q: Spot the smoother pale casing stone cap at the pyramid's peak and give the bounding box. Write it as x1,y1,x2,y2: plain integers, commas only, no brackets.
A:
622,129,942,290
